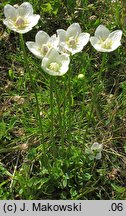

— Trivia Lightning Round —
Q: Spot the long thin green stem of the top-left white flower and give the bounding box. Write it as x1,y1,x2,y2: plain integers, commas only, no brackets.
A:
20,34,46,157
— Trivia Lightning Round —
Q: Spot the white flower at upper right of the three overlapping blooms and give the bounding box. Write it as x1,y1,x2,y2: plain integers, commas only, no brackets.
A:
57,23,90,55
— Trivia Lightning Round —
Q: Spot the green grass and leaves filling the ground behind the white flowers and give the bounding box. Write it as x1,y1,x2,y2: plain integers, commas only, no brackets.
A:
0,0,126,200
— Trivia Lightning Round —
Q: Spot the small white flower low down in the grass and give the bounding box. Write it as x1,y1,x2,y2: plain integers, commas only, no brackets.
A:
91,142,103,160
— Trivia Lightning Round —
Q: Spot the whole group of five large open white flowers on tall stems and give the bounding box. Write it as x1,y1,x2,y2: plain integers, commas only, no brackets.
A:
3,2,122,76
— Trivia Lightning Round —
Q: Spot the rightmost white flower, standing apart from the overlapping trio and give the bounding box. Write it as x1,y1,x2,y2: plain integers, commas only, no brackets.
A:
90,25,122,52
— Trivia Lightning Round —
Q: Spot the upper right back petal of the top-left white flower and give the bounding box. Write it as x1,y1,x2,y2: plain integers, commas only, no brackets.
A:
17,2,33,17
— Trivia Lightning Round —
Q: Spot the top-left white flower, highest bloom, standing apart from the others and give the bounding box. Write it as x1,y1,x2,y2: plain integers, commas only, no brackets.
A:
3,2,40,34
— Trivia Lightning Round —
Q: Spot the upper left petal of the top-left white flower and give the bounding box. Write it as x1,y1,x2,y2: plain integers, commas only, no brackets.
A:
4,4,17,21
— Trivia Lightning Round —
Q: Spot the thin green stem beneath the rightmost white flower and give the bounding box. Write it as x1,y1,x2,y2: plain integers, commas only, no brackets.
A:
83,53,106,144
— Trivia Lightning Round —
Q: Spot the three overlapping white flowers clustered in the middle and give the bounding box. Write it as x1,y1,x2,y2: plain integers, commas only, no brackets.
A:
26,23,89,76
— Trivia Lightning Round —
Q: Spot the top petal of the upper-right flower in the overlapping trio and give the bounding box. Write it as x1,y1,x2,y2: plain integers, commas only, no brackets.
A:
66,23,81,38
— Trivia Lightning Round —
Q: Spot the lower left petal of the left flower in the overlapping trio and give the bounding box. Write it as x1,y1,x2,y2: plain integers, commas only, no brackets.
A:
26,41,43,59
